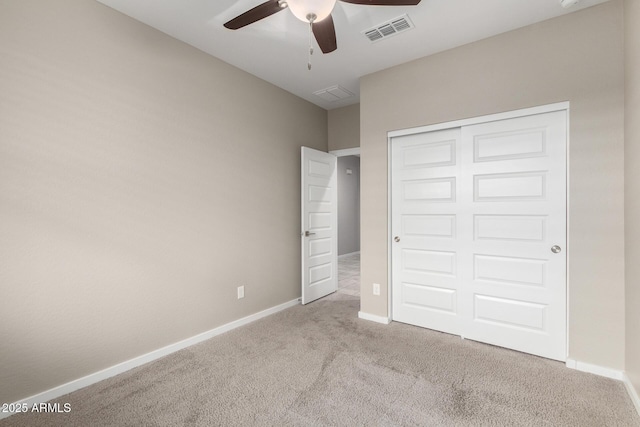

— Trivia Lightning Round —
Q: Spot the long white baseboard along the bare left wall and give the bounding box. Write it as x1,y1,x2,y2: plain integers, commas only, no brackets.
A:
0,299,300,420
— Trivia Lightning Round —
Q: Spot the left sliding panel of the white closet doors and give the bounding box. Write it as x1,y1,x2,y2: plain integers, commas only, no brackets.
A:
391,129,461,334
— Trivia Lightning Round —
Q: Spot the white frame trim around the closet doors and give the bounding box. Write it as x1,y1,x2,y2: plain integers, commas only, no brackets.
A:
387,101,571,363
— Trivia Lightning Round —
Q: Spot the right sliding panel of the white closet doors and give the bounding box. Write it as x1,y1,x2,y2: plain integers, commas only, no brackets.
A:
459,111,567,360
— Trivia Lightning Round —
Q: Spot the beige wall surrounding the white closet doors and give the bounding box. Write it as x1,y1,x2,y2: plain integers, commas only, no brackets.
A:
360,0,625,369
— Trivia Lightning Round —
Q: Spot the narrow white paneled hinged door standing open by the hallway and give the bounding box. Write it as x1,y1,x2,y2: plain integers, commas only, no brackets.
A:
301,147,338,304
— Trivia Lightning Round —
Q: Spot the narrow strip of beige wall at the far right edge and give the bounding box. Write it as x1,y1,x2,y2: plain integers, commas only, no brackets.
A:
624,0,640,395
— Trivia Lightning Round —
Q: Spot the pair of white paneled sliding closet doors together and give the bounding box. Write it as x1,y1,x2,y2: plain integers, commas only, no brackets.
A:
391,111,567,361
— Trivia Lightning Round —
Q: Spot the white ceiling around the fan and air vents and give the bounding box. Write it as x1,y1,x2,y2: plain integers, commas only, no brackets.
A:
92,0,607,110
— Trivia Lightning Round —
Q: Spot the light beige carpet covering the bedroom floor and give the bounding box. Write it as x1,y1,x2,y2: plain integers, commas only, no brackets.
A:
0,293,640,427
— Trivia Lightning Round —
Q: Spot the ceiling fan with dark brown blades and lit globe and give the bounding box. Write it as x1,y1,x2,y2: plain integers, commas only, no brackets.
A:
224,0,420,53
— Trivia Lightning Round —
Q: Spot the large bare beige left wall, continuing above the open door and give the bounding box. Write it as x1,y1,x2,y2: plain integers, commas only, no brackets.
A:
0,0,327,402
